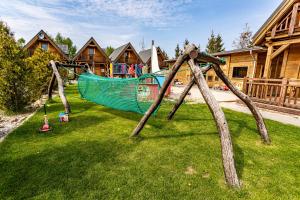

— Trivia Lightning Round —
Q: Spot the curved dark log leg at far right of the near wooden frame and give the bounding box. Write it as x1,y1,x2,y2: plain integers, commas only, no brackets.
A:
213,64,271,144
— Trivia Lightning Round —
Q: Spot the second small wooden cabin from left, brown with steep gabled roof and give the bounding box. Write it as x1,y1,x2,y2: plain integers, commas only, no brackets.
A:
73,37,110,76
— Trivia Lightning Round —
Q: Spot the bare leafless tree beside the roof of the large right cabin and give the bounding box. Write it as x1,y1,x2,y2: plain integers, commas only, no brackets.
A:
233,23,253,49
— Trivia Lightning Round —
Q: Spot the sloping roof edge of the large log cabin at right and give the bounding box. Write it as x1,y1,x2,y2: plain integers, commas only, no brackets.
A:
253,0,298,45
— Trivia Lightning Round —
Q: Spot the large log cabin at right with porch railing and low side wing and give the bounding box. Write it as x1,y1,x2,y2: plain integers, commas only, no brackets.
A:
213,0,300,114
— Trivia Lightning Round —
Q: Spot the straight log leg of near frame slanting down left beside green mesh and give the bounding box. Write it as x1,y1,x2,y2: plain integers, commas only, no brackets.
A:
131,45,197,137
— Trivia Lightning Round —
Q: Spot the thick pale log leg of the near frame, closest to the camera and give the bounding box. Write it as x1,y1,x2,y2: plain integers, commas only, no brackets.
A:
188,59,240,188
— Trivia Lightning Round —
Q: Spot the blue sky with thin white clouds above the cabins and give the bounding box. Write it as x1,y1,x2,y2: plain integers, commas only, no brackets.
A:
0,0,282,57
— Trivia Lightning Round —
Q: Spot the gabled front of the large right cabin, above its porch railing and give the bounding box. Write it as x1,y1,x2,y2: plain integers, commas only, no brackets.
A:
254,0,300,79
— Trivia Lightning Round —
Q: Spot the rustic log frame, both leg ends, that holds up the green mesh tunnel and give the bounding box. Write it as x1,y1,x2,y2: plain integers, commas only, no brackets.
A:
48,44,271,188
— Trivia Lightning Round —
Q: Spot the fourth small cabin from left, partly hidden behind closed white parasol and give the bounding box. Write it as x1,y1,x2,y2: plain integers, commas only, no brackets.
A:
139,47,168,69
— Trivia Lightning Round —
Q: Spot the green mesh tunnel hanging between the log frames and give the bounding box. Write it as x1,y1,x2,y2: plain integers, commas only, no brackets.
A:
78,73,161,114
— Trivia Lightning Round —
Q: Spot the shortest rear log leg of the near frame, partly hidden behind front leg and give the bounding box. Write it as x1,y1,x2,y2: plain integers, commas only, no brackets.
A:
167,65,212,120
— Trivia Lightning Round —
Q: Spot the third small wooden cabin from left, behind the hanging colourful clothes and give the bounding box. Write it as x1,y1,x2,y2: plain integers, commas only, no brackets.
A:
109,42,143,78
